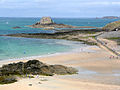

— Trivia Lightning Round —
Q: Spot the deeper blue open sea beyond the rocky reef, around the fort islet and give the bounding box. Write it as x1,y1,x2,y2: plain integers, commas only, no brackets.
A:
0,18,119,34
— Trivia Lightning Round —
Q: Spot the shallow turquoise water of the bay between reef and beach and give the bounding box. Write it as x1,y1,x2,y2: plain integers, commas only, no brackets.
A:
0,37,86,60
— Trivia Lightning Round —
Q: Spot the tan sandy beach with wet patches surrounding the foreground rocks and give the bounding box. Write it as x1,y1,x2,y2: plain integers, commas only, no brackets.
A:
0,46,120,90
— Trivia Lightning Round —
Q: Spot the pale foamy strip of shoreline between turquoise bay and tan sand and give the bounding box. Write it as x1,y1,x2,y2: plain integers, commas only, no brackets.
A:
0,45,98,66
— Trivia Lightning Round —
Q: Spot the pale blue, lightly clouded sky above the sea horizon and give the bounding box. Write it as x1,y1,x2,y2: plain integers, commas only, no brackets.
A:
0,0,120,17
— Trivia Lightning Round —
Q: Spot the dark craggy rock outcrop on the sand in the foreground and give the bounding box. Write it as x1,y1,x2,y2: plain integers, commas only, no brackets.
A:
0,60,77,84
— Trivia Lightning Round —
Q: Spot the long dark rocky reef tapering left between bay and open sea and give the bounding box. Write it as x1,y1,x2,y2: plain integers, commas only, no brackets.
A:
3,29,101,45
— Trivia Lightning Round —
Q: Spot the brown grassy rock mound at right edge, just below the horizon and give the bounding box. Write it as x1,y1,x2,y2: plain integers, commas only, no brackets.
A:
103,21,120,31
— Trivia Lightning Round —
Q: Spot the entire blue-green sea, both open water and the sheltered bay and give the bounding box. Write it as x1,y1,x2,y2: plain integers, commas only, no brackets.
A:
0,17,119,61
